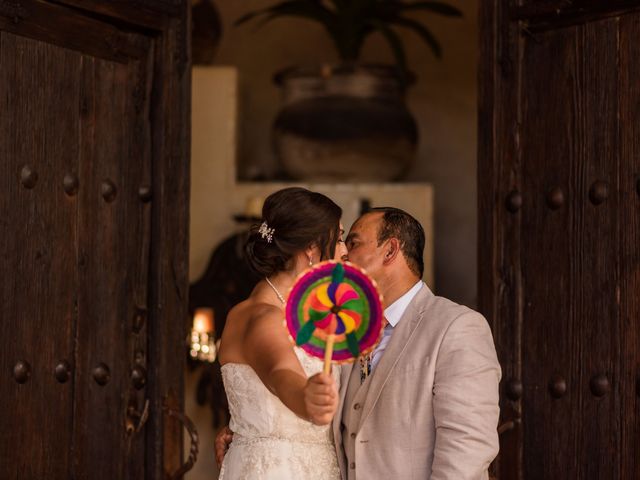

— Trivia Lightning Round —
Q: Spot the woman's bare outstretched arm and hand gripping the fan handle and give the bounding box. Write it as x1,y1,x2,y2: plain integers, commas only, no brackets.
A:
243,307,338,425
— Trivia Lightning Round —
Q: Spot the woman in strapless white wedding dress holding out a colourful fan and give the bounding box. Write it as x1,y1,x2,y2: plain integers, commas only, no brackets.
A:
219,188,347,480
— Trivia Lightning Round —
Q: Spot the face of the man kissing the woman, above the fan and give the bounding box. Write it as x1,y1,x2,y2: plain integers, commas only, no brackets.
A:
346,212,384,281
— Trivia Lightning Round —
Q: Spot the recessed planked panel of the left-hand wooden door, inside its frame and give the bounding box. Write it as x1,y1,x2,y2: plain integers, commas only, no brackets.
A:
0,27,152,478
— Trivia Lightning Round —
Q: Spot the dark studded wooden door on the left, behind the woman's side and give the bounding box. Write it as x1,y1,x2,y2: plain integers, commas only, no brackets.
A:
0,1,189,480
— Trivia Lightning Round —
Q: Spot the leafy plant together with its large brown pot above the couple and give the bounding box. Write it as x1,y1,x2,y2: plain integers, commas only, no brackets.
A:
236,0,462,181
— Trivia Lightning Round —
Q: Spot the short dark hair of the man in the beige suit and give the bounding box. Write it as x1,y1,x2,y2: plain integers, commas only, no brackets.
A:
367,207,425,278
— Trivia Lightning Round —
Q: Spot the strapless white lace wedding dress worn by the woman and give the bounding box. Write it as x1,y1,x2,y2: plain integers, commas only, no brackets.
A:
219,347,340,480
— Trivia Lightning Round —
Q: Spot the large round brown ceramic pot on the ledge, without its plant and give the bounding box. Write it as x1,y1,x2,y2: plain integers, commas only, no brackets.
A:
273,65,418,182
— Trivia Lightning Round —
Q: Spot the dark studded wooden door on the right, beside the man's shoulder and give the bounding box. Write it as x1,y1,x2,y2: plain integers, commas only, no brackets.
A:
478,0,640,480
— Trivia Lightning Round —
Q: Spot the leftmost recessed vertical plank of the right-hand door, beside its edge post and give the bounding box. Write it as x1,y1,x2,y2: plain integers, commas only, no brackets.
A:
520,29,580,479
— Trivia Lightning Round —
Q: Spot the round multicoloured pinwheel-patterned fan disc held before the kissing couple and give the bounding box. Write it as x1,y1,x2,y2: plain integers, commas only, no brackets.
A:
286,260,383,363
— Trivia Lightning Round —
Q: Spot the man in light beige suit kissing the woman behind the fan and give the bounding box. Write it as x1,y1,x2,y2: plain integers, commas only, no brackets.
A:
216,208,500,480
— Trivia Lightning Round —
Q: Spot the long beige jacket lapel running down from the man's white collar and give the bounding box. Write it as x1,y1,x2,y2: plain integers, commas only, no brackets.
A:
359,285,433,427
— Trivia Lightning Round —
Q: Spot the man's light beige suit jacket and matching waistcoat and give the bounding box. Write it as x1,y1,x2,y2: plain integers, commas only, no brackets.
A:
333,286,500,480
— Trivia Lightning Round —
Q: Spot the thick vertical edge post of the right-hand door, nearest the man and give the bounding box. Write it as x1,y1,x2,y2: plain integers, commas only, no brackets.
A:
478,0,522,479
